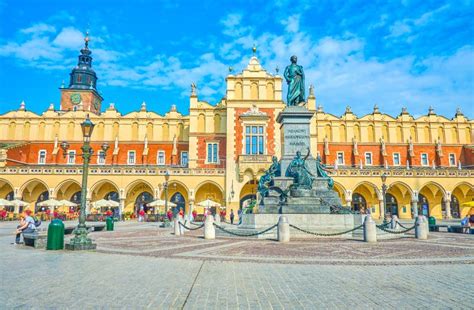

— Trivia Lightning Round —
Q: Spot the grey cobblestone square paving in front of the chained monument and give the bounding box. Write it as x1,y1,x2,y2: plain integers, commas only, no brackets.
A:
0,223,474,309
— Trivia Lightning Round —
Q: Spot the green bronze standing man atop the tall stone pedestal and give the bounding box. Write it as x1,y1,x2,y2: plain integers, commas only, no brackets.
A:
283,55,305,106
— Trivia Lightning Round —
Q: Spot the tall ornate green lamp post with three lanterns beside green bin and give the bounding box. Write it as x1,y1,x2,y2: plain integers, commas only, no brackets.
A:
61,115,109,250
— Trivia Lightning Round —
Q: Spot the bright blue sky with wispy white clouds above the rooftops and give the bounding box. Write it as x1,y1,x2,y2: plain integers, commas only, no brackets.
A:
0,0,474,118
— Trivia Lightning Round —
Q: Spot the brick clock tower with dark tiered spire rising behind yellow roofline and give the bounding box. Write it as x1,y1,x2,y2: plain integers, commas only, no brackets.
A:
60,33,103,114
